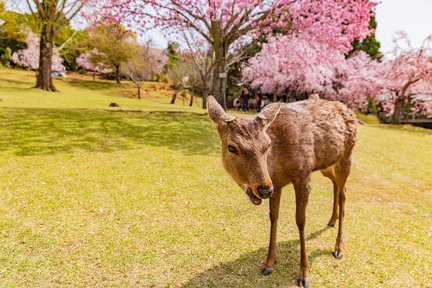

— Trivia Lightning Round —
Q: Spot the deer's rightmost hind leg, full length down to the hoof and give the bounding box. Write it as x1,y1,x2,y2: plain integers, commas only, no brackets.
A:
333,157,351,259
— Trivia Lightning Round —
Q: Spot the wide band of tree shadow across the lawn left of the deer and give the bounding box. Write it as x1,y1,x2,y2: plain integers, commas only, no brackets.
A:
0,108,219,156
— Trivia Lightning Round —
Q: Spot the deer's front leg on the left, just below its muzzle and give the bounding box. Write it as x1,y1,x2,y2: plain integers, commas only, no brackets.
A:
261,188,282,275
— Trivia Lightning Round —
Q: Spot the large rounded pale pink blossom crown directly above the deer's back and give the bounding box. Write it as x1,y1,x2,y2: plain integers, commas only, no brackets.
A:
243,35,343,98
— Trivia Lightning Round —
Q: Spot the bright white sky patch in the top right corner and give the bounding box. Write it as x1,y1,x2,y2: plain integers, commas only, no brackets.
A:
376,0,432,53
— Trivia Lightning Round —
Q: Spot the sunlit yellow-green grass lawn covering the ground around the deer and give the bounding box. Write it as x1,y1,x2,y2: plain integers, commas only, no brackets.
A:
0,69,432,287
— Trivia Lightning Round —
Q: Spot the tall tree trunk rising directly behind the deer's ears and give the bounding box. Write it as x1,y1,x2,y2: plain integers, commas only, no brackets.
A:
212,21,228,110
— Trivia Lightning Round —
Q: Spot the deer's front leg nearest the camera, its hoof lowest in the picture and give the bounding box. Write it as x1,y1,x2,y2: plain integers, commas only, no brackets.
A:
294,175,310,288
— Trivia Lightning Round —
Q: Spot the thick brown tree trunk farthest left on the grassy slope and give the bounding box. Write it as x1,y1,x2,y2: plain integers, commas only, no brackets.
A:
36,22,57,92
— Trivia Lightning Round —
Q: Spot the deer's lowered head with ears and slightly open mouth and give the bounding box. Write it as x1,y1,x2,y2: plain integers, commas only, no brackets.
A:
207,96,280,205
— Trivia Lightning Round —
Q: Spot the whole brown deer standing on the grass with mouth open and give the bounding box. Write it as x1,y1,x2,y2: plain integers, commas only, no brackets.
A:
207,96,357,287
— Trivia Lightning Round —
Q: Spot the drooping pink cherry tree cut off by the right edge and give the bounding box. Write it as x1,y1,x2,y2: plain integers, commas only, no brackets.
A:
378,32,432,123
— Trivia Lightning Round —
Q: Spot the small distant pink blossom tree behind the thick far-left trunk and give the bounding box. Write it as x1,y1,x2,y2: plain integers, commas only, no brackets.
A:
12,29,66,72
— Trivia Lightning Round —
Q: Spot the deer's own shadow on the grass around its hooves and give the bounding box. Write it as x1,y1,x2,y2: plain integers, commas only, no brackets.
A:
181,227,331,288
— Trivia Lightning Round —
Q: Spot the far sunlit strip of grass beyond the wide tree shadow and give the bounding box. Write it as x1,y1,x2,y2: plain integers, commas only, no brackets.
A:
0,69,202,113
